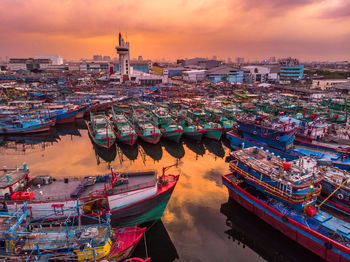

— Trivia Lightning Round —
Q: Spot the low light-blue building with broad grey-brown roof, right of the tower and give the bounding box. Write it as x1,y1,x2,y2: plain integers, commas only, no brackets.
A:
206,66,243,84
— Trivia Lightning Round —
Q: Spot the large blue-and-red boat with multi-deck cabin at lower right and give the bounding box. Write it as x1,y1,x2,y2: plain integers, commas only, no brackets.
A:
222,147,350,261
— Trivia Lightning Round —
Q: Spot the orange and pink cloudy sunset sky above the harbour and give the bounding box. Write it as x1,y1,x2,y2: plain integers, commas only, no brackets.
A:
0,0,350,61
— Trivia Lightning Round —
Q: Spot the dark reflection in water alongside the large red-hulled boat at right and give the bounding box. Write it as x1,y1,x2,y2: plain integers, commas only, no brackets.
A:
220,199,323,262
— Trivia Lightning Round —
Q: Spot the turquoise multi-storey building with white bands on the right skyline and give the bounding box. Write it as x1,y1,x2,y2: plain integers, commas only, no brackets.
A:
278,57,304,83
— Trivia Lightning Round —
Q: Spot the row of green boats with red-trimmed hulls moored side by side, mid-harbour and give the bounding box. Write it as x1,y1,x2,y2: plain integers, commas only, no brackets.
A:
87,101,235,148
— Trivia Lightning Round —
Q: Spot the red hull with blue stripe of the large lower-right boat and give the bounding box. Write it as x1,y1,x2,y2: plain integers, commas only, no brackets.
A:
223,175,350,261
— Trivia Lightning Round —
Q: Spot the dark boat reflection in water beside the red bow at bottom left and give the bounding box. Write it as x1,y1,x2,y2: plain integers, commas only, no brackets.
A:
132,220,179,262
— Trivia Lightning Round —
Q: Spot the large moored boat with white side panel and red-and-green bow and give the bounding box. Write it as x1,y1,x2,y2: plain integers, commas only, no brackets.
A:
0,164,179,227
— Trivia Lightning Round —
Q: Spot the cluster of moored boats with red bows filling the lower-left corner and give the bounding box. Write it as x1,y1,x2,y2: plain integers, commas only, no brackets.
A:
0,164,179,261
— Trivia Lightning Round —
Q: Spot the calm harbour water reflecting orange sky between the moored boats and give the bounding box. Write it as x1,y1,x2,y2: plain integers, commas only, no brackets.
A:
0,122,319,262
